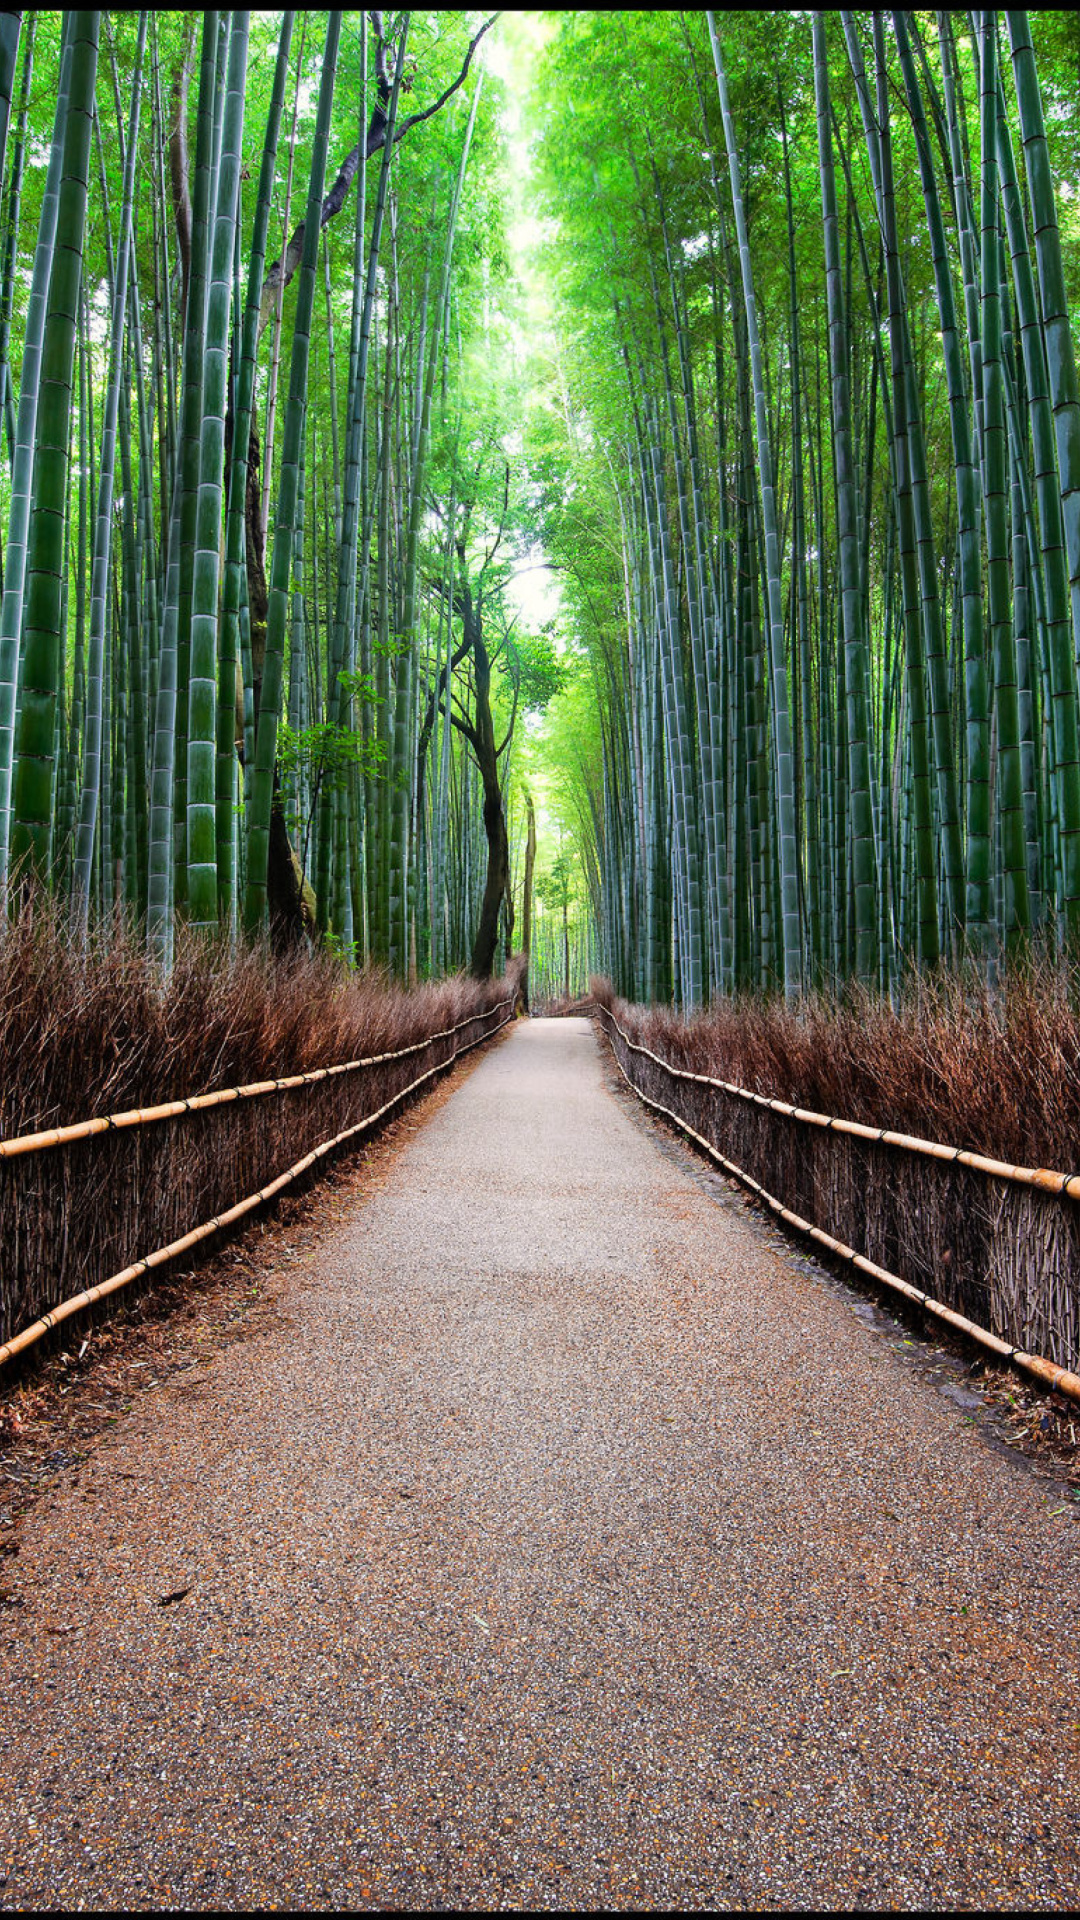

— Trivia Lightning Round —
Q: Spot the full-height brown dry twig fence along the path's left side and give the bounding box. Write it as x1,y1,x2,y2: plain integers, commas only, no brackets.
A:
0,904,517,1344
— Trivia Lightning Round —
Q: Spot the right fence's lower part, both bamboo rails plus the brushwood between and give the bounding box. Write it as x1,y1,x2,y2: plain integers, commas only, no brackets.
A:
596,989,1080,1400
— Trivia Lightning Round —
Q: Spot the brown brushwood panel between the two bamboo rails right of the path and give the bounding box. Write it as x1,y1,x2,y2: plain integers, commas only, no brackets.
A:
598,1006,1080,1371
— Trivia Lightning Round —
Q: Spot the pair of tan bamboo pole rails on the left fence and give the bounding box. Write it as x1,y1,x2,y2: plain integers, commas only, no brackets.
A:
0,995,515,1367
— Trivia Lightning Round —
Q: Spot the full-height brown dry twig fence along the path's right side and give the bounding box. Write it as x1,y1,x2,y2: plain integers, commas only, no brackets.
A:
594,970,1080,1379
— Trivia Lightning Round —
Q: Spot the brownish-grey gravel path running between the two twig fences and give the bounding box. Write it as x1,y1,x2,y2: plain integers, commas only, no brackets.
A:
0,1020,1080,1908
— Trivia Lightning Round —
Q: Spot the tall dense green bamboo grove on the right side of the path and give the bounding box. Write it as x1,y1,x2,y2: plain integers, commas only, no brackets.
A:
538,12,1080,1006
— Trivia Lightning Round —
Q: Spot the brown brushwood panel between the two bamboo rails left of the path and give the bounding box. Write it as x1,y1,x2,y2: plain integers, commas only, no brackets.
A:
0,981,507,1342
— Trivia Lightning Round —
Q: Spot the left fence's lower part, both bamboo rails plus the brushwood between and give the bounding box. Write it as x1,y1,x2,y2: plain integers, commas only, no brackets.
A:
0,995,513,1365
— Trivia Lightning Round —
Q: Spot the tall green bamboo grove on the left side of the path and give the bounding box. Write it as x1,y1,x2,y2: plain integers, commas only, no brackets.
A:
0,12,553,977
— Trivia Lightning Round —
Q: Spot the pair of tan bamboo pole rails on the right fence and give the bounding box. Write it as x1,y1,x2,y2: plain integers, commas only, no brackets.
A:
598,1002,1080,1404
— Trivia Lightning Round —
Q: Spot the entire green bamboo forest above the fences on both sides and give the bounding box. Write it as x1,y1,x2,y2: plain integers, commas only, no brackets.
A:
0,12,1080,1010
